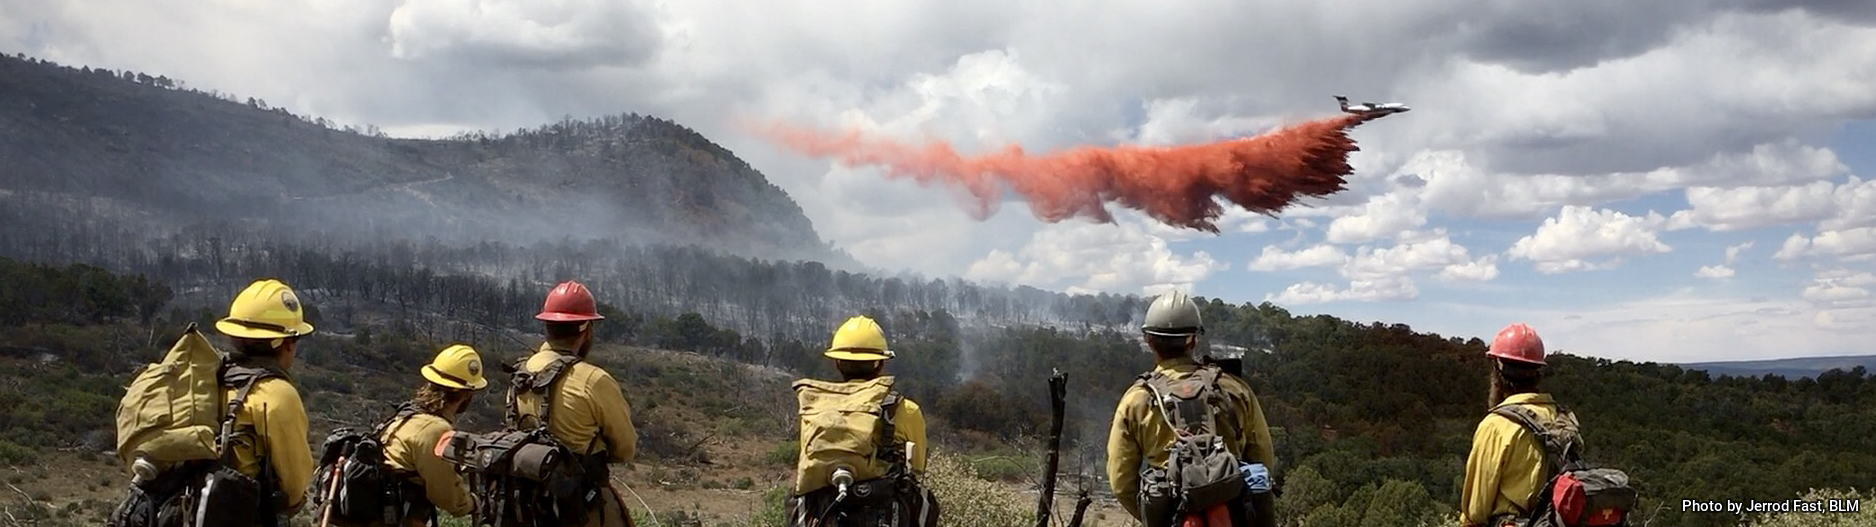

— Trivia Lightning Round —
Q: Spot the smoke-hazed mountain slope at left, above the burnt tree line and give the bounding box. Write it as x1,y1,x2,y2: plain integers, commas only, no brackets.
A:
0,56,850,264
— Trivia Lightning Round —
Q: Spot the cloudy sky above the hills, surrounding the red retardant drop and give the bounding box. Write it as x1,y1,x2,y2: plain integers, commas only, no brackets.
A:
0,0,1876,362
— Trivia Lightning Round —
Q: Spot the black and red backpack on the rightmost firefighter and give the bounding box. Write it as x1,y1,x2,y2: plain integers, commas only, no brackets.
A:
1491,405,1636,527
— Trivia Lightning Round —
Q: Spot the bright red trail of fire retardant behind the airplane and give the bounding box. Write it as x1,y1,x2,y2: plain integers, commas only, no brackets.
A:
758,114,1377,234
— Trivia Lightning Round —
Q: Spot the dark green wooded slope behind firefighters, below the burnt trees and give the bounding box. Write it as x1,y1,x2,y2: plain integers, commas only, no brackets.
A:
0,255,1876,527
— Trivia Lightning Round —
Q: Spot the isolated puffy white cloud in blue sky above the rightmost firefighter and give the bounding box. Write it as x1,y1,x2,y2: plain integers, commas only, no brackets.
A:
1506,206,1672,274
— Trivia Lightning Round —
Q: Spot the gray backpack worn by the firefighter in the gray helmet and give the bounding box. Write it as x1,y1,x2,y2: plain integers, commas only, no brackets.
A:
1135,364,1246,527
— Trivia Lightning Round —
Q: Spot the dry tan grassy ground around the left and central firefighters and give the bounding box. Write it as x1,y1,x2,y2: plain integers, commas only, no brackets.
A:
0,341,1131,527
